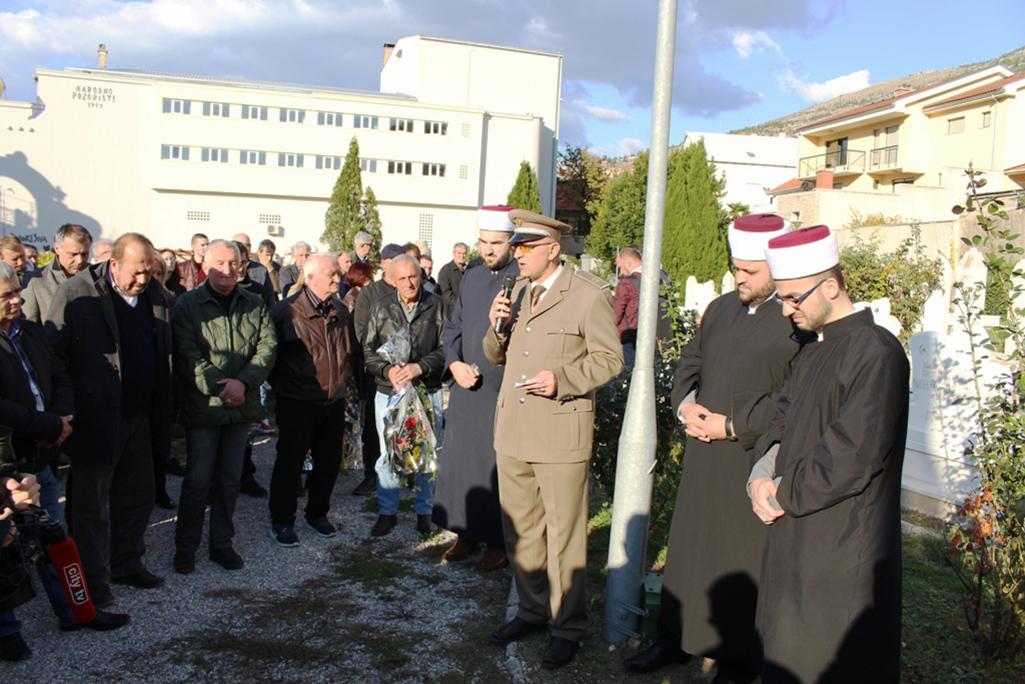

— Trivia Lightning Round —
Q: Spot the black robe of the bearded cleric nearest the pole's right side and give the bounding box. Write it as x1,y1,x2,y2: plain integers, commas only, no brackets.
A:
659,291,809,668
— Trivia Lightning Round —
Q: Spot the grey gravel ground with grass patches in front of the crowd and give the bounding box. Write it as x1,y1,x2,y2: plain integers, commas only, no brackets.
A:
3,440,705,684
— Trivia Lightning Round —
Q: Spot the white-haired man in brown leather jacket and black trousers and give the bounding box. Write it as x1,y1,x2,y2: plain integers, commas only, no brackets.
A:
271,253,359,547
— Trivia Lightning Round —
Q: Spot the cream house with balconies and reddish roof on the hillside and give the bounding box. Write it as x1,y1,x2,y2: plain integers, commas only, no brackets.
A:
770,66,1025,251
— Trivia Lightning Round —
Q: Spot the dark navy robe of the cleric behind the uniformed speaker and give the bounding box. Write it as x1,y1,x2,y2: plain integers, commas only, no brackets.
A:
433,256,520,549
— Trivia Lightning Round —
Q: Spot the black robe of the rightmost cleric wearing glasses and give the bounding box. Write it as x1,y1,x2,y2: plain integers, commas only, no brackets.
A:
756,311,909,684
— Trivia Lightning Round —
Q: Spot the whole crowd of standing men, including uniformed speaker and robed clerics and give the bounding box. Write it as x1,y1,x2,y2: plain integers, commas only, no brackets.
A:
0,206,908,683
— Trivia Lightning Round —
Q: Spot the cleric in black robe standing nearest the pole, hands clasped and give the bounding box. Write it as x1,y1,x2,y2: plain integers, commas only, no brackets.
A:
624,214,804,681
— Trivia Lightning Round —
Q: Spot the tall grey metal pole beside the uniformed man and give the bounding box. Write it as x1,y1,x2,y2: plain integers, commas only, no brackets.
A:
602,0,677,644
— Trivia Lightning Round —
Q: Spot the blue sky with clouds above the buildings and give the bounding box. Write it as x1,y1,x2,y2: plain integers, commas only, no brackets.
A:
6,0,1025,155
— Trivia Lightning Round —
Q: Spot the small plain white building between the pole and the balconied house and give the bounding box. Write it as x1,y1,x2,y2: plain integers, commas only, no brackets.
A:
683,132,797,212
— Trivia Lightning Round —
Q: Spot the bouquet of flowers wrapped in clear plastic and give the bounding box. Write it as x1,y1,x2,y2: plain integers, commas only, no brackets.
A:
376,330,438,488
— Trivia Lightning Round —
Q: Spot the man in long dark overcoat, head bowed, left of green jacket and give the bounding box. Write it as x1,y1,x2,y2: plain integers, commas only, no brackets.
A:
45,233,171,607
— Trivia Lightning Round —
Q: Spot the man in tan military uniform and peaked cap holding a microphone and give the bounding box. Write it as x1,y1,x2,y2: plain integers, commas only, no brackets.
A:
483,209,623,669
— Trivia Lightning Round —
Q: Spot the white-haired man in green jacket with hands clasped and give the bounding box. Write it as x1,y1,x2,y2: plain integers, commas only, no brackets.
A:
171,240,278,573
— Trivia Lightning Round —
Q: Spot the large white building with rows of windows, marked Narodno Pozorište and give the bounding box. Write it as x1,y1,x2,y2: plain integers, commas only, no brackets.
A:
0,36,563,254
